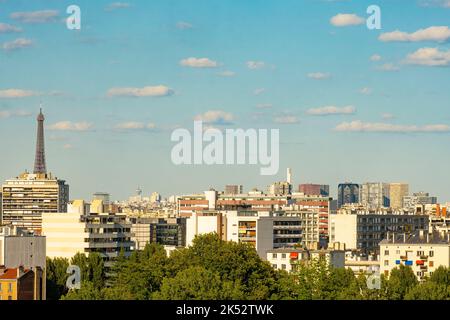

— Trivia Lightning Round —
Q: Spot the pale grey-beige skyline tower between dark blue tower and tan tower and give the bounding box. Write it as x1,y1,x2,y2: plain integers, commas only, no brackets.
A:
359,182,390,209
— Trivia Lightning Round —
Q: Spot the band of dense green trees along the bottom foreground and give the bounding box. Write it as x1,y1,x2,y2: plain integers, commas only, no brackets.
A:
54,234,450,300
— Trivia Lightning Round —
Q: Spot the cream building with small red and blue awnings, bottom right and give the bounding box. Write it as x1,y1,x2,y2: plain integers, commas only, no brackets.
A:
380,230,450,281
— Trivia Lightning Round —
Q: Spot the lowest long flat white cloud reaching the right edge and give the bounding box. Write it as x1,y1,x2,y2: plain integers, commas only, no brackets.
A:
335,120,450,133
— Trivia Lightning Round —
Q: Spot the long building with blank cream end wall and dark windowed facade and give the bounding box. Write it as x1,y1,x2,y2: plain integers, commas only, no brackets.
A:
330,211,429,253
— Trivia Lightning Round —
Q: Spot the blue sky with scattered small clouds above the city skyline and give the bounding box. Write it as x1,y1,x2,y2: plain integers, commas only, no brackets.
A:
0,0,450,201
